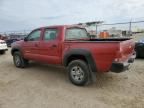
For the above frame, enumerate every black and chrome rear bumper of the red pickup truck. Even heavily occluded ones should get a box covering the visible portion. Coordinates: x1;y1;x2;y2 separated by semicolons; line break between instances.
110;53;136;73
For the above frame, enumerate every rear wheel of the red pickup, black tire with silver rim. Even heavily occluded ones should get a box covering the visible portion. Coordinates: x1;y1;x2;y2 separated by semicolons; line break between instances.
67;60;90;86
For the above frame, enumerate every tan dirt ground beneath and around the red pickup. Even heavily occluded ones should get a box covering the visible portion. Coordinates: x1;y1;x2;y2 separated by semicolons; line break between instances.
0;36;144;108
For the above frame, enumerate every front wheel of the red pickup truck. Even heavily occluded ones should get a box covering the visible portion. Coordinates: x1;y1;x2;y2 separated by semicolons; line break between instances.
13;51;28;68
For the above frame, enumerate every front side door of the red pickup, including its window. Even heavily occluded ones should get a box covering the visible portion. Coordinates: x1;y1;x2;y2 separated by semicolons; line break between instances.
23;29;41;60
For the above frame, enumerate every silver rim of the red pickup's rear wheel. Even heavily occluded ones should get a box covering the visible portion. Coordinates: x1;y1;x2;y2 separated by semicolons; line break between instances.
71;66;84;82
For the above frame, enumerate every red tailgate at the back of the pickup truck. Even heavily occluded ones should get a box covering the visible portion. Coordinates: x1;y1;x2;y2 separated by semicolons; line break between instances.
119;39;135;61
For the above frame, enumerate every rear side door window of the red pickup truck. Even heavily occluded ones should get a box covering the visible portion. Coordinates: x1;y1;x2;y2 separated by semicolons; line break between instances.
44;29;58;41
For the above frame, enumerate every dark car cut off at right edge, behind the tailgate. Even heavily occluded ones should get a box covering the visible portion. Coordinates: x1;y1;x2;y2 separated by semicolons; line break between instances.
135;39;144;58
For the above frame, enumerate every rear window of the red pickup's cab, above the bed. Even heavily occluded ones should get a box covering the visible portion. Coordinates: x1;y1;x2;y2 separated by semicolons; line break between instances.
66;28;88;40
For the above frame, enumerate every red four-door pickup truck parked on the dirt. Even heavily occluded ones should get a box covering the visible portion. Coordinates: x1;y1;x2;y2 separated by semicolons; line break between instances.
11;25;135;85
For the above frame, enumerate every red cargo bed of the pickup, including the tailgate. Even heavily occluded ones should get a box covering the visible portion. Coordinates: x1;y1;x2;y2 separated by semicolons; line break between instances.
65;38;134;72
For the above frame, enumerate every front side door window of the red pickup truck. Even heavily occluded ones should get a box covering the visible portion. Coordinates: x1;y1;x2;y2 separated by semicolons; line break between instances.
27;30;41;41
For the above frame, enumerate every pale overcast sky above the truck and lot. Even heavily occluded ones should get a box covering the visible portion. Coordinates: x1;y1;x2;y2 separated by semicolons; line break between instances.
0;0;144;32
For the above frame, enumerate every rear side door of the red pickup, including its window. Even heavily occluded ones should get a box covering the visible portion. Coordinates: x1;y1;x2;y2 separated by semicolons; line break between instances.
40;28;61;64
